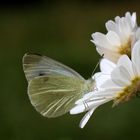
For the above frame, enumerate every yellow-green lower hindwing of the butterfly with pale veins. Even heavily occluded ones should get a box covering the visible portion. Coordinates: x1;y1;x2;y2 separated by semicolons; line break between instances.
28;75;85;118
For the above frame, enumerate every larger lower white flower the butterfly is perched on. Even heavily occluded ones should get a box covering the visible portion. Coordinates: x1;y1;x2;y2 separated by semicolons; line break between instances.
70;41;140;128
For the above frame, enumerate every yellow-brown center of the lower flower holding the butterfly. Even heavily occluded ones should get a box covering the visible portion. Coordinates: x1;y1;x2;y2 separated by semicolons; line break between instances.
113;77;140;106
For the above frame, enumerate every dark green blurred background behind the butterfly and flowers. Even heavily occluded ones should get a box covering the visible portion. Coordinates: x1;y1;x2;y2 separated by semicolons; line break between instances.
0;0;140;140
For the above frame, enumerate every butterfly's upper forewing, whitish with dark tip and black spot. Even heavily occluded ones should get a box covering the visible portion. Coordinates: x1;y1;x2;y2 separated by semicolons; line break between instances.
23;54;84;82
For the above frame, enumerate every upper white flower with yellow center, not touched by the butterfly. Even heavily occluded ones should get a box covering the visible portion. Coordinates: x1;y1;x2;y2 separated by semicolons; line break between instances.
91;12;140;63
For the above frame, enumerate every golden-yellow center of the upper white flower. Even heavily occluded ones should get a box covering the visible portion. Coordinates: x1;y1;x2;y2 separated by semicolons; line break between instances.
119;39;131;57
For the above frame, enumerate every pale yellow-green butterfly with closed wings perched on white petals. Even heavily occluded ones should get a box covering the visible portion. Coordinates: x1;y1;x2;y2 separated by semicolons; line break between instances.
23;53;95;118
